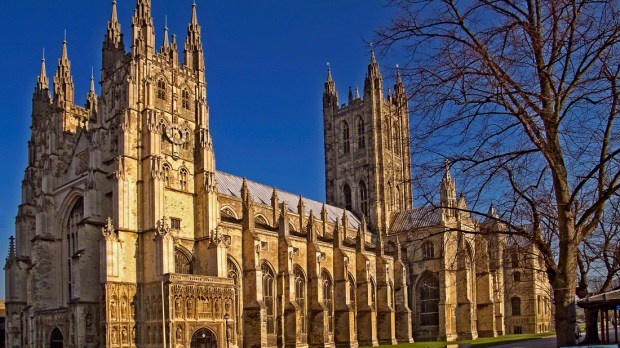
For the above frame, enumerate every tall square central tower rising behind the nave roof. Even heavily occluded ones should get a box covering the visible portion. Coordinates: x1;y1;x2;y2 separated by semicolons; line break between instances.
323;51;413;233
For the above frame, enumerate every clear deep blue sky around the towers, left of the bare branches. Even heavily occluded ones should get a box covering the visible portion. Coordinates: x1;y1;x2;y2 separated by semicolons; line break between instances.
0;0;398;298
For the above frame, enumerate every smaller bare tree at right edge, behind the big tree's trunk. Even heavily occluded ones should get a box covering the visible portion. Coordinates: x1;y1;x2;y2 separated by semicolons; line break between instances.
577;196;620;343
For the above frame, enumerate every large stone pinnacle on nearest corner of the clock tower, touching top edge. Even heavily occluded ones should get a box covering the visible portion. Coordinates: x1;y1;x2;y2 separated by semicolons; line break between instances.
131;0;155;58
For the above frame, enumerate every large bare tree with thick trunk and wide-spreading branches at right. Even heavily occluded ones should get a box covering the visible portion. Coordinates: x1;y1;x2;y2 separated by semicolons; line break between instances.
378;0;620;345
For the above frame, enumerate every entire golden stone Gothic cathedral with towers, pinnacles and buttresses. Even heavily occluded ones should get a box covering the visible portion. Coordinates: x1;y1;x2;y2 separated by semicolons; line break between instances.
4;0;551;348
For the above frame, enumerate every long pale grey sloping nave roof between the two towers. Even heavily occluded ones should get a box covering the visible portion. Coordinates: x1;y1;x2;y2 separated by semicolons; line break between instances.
215;171;360;229
